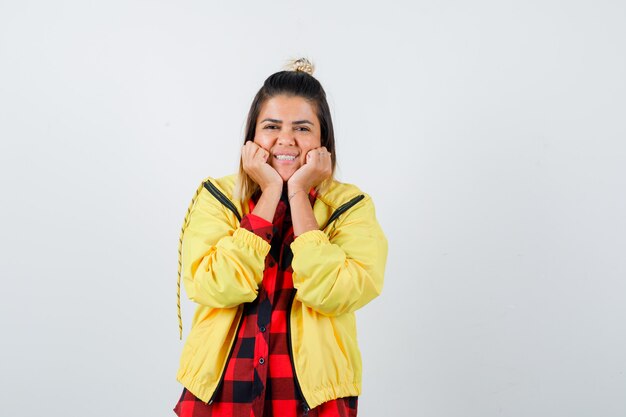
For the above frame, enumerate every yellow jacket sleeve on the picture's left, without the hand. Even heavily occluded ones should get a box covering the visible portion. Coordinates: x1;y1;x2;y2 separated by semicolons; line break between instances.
182;184;270;308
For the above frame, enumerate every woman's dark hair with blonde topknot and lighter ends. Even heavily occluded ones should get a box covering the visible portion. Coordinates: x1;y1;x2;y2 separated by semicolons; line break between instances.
234;58;337;203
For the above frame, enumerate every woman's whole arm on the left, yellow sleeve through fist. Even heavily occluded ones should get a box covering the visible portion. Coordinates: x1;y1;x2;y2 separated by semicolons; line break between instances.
182;141;283;308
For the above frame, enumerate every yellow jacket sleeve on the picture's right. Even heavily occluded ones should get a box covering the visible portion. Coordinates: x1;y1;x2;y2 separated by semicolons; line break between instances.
291;196;387;316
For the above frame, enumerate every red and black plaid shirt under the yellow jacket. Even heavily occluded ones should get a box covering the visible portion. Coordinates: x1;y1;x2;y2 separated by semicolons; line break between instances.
174;189;358;417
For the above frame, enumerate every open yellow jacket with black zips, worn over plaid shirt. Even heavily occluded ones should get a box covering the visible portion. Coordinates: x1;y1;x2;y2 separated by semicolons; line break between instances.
176;174;387;408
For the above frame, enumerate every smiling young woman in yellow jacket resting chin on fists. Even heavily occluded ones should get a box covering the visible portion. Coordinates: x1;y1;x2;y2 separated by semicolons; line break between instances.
174;59;387;417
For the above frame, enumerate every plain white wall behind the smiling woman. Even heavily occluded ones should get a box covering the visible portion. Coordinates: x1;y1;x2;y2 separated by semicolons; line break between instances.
0;0;626;417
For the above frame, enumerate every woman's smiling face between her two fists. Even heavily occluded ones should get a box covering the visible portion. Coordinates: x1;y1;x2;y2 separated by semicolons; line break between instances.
254;95;321;181
